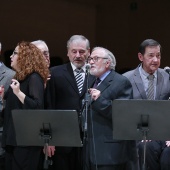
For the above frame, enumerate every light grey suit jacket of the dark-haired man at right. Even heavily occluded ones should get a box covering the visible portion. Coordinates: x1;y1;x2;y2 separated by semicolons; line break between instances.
123;67;170;100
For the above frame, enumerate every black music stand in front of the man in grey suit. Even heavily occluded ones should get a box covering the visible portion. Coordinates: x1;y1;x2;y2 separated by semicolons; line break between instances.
112;99;170;169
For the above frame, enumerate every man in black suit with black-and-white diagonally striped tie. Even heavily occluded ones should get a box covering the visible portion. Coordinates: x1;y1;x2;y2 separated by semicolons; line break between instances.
46;35;94;170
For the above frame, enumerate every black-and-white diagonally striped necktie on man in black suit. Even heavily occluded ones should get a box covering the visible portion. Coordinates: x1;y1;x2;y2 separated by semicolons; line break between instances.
75;68;83;93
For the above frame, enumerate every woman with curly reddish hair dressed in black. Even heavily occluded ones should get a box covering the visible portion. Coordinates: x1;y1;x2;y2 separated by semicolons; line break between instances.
0;42;49;170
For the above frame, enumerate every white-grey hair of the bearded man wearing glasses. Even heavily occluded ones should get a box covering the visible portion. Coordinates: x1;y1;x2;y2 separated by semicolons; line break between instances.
92;47;116;70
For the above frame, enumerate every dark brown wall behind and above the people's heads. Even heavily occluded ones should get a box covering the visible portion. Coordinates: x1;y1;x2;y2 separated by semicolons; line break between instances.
0;0;170;72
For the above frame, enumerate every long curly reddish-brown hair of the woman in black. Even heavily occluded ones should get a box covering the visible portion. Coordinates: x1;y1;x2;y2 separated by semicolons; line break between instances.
15;41;49;82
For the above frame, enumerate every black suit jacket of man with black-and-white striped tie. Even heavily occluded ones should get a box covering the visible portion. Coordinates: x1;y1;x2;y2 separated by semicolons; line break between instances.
45;63;94;112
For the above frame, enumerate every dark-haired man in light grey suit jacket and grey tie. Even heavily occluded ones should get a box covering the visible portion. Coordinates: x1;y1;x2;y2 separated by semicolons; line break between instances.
123;39;170;170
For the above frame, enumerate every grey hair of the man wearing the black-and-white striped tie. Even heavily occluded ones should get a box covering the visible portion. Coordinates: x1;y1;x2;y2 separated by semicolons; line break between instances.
67;35;90;49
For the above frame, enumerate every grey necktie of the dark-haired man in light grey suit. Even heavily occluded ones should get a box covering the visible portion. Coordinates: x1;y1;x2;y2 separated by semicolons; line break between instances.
147;74;154;100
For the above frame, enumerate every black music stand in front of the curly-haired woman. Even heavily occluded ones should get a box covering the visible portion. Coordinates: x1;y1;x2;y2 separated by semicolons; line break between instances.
12;110;82;169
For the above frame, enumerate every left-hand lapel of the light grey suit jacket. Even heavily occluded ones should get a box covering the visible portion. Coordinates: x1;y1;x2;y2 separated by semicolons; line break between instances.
133;67;147;99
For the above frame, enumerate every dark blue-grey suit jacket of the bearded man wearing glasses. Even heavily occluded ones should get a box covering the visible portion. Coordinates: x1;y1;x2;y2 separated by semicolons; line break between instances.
87;70;135;165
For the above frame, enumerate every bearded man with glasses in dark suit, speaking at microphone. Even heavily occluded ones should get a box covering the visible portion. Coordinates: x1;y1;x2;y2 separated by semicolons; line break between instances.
86;47;135;170
